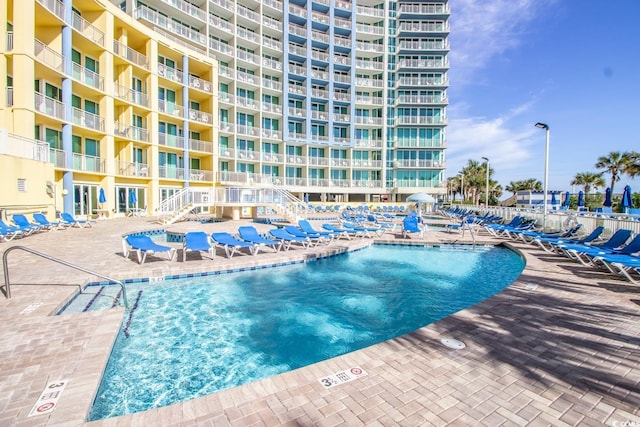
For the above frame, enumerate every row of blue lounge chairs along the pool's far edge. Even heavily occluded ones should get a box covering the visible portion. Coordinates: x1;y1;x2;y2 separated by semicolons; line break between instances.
122;220;368;264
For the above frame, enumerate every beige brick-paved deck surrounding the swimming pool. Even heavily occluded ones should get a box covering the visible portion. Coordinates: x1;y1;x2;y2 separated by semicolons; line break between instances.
0;218;640;426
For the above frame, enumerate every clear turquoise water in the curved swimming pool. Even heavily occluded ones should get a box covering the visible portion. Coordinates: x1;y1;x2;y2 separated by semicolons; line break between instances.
77;245;524;420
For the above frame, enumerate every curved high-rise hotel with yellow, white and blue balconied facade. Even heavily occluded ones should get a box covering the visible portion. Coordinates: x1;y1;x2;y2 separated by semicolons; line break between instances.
0;0;449;219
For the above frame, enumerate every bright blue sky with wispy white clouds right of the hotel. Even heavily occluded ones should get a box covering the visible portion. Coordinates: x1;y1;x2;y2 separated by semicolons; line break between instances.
446;0;640;198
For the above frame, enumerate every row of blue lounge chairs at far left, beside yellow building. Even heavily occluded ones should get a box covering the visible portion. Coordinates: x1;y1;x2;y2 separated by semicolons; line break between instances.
0;212;95;241
